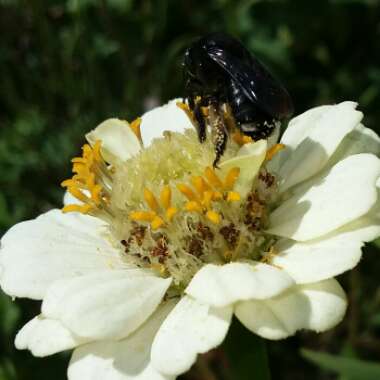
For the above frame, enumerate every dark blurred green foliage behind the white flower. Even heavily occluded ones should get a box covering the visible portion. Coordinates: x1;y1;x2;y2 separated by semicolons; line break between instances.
0;0;380;380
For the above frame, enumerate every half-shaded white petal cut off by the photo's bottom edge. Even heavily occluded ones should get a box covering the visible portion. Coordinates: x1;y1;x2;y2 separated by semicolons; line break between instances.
68;303;174;380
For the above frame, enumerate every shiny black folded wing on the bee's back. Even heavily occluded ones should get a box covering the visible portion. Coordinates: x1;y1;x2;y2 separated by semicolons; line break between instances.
207;46;293;118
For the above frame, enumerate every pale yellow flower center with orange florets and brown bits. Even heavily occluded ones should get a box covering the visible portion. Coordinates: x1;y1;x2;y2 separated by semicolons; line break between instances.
62;123;278;289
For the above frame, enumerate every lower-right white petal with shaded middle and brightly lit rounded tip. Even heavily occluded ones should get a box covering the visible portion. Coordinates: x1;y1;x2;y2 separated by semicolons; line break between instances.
235;279;347;339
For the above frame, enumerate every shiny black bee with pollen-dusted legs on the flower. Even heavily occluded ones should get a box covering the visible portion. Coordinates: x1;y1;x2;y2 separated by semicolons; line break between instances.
183;33;293;166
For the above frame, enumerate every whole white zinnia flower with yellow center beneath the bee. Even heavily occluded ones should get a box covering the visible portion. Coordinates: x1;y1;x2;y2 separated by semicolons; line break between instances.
0;102;380;380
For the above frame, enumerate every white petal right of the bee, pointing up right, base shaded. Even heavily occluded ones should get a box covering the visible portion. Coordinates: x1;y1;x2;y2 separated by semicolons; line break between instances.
279;102;363;191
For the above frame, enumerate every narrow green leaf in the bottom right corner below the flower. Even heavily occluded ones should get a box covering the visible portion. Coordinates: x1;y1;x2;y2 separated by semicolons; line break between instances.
301;349;380;380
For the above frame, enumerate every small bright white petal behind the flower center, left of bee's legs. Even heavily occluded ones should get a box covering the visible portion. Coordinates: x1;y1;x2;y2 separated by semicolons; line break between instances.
140;99;194;147
